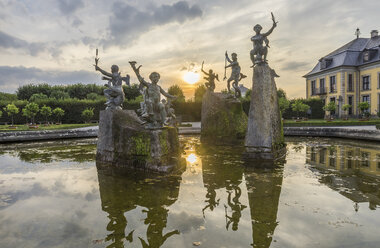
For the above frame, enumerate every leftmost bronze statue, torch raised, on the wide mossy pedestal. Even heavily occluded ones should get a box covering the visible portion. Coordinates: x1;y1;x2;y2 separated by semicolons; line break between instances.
94;51;129;109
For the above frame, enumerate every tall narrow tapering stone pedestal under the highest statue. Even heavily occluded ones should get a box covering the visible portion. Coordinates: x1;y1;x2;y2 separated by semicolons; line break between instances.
245;64;284;159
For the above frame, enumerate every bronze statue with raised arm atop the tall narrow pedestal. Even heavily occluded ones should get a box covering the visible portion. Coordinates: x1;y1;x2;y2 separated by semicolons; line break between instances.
250;13;277;67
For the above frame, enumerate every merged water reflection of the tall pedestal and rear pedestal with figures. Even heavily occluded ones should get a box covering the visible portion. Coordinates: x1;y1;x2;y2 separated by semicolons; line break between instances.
198;142;284;247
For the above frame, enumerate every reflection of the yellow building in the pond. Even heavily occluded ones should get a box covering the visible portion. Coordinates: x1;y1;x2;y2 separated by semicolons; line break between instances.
306;140;380;211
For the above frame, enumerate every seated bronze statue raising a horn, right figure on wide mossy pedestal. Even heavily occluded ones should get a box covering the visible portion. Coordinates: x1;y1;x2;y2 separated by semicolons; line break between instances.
129;61;176;129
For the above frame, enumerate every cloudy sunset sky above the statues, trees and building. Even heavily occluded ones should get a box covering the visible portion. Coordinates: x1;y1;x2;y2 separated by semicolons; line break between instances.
0;0;380;99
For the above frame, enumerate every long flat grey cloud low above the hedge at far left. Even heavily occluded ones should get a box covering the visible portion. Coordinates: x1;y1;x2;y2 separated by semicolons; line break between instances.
0;66;100;92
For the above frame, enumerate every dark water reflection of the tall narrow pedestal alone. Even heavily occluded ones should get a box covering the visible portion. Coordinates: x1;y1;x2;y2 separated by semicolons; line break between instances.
244;157;285;247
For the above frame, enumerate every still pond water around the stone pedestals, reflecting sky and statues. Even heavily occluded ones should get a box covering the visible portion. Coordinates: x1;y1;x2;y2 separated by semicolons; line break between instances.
0;136;380;248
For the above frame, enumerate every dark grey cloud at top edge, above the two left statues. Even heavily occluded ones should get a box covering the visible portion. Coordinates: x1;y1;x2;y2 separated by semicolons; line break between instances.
104;1;203;45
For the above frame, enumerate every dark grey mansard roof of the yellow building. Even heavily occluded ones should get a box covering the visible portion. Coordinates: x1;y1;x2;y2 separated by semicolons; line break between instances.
305;36;380;77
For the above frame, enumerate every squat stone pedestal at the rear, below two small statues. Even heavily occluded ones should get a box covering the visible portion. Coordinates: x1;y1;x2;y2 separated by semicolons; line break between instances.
201;90;247;144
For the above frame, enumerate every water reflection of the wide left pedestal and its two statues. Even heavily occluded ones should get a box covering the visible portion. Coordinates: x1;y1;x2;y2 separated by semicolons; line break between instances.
97;167;181;248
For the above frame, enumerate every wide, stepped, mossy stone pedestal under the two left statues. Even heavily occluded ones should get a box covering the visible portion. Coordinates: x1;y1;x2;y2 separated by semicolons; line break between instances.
96;109;183;172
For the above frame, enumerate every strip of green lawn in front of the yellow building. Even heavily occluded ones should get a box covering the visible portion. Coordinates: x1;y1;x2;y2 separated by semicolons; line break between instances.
284;119;380;127
